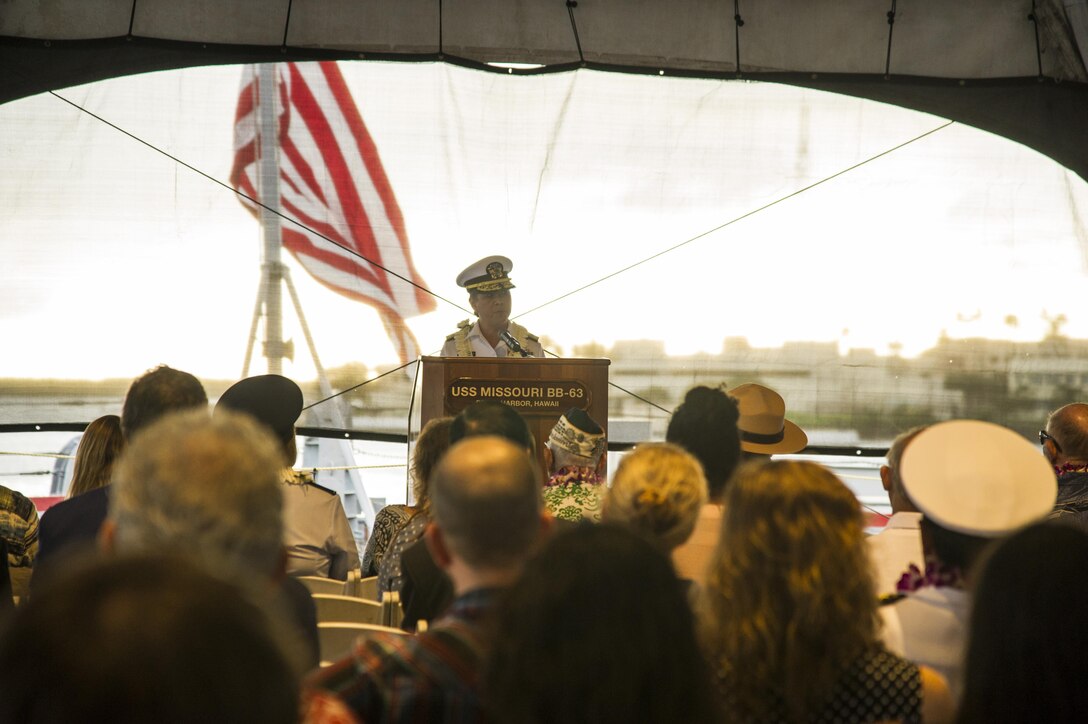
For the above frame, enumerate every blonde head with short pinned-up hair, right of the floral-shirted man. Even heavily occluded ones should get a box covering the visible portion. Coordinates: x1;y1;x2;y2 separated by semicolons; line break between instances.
603;442;707;553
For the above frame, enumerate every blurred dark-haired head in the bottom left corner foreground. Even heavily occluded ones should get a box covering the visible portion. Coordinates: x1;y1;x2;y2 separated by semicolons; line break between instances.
0;556;298;724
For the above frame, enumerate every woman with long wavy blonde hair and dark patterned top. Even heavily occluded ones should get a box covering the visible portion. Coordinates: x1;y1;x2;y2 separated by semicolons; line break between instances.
700;462;953;722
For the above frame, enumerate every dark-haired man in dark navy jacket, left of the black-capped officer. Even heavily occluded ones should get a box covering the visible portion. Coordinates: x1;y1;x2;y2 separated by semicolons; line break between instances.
30;365;208;588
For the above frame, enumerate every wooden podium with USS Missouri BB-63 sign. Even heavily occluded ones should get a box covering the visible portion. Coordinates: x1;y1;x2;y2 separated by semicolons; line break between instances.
420;357;610;469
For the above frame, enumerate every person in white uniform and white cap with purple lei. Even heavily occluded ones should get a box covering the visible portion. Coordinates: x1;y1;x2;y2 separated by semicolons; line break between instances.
881;420;1056;700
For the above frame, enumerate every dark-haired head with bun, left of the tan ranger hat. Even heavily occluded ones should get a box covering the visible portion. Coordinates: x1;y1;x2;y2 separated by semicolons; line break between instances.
665;385;741;500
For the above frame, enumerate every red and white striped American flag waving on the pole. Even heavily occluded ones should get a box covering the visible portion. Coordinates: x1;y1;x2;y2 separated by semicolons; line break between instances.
231;62;434;364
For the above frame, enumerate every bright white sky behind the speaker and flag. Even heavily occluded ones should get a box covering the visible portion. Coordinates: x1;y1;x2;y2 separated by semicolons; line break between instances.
0;63;1088;379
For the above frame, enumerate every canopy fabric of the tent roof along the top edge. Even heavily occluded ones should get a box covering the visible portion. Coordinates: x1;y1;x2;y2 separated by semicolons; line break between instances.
0;0;1088;179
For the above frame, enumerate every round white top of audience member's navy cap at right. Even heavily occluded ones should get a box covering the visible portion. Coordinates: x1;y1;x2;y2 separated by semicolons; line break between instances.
900;420;1058;538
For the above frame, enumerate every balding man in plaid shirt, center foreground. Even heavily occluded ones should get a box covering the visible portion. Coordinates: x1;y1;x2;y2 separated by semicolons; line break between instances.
304;435;551;722
